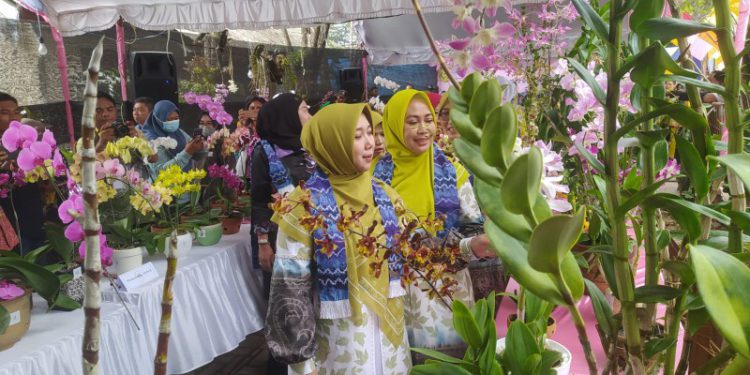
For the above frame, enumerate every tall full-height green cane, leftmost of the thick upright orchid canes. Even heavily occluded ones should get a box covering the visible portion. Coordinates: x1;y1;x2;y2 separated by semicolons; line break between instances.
604;0;643;373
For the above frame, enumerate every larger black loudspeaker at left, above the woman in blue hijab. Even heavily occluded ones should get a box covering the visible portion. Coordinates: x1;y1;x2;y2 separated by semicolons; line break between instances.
130;52;178;104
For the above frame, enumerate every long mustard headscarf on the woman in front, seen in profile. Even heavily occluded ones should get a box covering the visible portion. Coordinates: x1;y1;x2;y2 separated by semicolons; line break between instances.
274;104;404;346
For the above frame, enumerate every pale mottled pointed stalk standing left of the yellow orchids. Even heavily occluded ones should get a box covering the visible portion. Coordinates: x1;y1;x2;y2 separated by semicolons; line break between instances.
78;37;104;375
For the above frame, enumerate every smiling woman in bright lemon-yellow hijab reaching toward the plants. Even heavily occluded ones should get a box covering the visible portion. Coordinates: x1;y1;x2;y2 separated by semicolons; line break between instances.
373;90;494;362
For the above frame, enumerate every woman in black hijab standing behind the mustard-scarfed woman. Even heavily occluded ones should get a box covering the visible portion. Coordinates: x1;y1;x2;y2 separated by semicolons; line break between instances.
251;94;315;374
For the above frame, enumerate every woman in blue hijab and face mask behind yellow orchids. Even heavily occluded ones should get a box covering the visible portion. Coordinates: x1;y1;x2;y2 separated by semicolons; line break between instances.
143;100;206;175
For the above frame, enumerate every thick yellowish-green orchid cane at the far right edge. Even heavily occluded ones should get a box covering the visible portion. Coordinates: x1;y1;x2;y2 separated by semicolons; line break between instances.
714;0;747;253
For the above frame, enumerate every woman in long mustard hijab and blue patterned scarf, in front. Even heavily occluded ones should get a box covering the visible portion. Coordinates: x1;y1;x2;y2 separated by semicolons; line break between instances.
266;104;411;374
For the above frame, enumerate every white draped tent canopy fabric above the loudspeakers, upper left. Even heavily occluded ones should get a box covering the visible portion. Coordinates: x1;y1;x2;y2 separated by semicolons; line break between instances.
17;0;453;36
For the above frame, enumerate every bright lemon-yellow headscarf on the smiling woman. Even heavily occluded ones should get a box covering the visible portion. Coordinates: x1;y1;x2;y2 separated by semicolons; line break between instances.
383;89;468;218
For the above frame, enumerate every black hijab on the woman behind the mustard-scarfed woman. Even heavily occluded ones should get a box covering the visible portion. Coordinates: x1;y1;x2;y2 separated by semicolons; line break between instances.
256;94;302;150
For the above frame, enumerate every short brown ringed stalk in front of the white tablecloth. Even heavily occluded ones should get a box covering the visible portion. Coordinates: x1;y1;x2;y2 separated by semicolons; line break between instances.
154;231;177;375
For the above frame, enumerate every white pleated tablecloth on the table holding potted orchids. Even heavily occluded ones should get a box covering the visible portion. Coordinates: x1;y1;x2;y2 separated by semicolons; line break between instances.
0;225;265;375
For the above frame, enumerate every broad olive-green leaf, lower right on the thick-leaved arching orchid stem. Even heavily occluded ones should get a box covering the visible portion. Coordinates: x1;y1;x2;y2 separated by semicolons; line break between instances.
529;208;586;274
